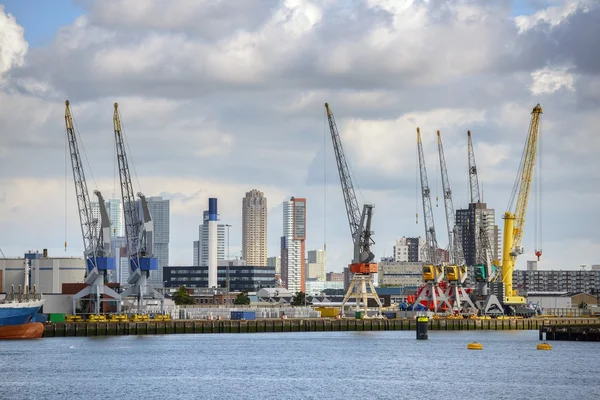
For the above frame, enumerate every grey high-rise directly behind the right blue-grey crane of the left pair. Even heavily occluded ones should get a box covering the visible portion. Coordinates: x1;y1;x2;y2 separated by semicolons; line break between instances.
146;196;170;287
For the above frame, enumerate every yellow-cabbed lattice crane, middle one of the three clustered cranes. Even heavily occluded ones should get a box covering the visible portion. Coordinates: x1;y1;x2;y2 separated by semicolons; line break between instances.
437;130;476;310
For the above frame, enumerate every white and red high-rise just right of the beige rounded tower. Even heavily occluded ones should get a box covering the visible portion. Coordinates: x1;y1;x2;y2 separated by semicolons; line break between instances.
281;197;306;292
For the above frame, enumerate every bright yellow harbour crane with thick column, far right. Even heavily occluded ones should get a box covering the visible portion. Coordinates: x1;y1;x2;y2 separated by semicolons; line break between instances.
502;104;542;305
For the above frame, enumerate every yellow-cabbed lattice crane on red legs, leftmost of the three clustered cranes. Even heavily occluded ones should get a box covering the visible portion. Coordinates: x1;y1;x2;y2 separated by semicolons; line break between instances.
413;128;452;311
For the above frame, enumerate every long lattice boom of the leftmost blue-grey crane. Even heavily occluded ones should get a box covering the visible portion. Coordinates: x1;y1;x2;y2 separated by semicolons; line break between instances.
65;100;98;260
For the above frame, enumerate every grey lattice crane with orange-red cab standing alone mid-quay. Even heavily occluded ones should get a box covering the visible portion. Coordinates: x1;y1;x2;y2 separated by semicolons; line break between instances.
325;103;382;317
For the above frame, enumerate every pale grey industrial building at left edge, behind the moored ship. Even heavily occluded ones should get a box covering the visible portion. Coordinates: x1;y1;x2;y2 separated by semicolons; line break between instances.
0;250;85;294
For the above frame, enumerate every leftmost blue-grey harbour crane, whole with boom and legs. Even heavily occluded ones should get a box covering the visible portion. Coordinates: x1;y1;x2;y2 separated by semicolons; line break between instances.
65;100;121;315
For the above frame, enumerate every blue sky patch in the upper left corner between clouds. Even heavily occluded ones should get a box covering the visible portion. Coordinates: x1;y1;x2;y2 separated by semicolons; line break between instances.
0;0;84;47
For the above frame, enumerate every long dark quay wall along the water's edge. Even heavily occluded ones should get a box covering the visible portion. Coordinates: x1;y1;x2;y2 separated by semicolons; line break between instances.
44;318;598;337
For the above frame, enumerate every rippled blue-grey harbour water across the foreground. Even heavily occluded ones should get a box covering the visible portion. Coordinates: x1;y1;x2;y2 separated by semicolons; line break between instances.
0;331;600;400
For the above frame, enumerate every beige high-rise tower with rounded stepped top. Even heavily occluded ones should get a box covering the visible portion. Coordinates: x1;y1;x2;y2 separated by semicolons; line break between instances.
242;189;267;266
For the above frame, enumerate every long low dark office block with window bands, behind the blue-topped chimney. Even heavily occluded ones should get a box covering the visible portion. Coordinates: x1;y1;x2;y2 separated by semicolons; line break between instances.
164;260;275;292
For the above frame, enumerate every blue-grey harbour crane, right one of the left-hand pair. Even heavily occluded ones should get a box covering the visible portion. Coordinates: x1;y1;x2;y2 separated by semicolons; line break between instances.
113;103;164;312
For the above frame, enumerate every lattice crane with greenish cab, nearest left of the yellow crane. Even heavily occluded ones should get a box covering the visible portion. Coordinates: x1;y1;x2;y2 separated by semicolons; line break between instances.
467;131;504;315
